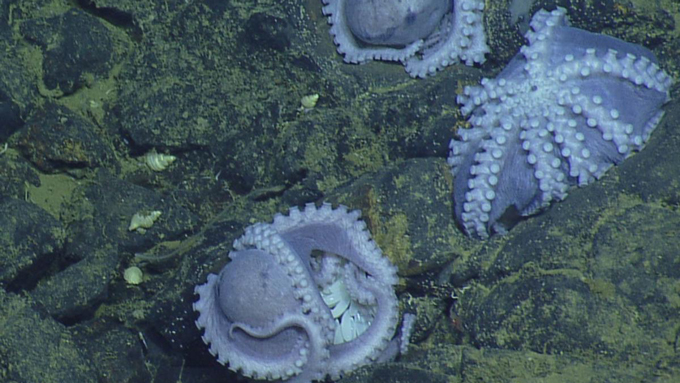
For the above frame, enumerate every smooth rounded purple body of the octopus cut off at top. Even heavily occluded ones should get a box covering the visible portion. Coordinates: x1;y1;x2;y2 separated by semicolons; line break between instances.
345;0;453;46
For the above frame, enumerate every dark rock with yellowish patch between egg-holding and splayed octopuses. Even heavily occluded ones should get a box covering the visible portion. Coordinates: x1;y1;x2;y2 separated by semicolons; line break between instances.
327;158;478;275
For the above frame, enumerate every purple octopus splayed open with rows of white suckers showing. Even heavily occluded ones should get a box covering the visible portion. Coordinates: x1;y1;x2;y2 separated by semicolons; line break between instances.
449;8;673;238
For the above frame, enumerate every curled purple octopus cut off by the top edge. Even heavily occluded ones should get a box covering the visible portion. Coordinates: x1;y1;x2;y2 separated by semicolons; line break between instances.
323;0;489;77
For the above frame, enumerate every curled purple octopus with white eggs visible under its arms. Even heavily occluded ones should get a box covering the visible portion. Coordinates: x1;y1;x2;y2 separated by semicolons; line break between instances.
194;204;414;382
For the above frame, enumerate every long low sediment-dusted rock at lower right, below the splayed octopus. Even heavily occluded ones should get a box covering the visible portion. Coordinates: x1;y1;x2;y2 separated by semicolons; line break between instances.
458;266;677;359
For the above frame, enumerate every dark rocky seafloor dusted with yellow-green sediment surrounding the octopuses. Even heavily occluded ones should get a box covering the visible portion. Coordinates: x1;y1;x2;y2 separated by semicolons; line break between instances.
0;0;680;383
